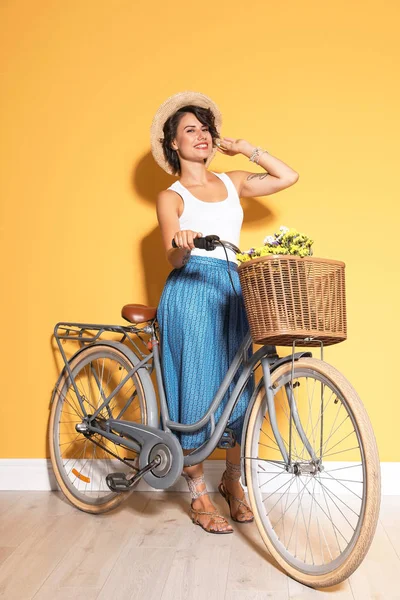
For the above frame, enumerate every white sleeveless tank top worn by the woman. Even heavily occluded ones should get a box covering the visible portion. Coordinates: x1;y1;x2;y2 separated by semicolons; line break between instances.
168;171;243;263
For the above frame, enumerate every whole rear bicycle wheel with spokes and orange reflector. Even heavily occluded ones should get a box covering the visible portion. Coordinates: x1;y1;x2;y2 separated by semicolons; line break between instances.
49;344;147;513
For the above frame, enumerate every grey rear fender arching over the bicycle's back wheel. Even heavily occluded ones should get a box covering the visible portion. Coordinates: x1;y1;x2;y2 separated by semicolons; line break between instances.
50;340;159;428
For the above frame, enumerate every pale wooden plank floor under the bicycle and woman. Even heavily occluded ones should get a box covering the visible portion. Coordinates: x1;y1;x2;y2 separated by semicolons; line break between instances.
0;492;400;600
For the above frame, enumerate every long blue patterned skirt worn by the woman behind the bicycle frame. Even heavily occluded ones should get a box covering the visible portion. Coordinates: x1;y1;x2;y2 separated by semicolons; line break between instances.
157;255;254;449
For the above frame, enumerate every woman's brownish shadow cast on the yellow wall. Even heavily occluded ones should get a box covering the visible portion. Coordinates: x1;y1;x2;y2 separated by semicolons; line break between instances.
132;152;274;306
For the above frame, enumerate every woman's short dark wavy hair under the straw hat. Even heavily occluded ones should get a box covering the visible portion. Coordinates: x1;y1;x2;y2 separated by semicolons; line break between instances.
160;104;219;175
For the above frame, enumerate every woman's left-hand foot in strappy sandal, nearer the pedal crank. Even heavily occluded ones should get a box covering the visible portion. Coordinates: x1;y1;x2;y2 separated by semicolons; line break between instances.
182;471;233;534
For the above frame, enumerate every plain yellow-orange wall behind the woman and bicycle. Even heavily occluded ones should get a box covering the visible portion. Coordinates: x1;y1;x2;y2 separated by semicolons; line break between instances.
0;0;400;461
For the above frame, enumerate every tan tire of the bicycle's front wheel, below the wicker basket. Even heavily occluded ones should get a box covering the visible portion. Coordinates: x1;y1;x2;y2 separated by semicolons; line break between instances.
245;358;381;588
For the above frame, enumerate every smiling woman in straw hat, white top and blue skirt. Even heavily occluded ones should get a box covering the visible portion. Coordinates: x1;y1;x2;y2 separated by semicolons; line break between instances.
151;92;299;533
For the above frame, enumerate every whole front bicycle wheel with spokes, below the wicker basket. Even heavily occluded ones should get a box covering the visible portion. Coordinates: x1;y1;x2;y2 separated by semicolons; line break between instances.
245;358;380;588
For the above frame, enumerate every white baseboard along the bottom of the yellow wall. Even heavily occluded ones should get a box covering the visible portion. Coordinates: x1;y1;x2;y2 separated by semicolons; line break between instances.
0;458;400;496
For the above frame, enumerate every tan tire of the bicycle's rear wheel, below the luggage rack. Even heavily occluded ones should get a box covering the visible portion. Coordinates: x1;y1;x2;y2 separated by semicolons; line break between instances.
49;344;146;514
